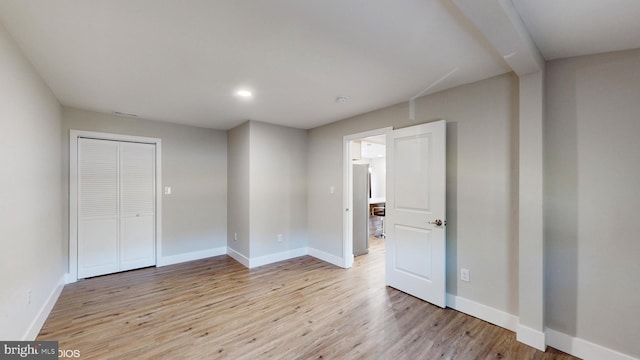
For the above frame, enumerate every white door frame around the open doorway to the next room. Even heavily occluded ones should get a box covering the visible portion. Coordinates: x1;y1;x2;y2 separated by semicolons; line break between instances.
342;126;393;269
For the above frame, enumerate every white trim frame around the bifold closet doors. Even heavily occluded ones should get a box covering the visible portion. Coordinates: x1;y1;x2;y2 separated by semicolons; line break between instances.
66;129;162;283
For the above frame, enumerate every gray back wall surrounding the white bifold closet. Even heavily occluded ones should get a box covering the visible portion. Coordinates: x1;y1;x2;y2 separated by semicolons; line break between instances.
62;107;227;258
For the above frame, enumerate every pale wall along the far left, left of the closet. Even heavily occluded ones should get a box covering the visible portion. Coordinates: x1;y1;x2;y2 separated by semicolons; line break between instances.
0;25;65;340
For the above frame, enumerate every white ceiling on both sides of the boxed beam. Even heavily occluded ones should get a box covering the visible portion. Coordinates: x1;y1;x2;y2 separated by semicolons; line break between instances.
0;0;640;129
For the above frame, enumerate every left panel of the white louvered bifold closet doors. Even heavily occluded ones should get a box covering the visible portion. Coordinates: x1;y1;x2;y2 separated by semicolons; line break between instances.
78;139;119;278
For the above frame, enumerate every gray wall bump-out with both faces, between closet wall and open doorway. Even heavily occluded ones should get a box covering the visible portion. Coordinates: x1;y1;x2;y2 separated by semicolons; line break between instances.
228;121;307;259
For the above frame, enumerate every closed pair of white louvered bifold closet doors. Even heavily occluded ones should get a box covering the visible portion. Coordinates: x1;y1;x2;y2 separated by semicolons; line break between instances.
78;138;156;278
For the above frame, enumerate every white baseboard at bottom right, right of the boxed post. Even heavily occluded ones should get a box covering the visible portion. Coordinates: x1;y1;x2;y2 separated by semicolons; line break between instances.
545;328;638;360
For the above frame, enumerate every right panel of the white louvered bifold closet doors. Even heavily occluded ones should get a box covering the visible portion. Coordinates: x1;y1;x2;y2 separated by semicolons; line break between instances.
120;142;156;271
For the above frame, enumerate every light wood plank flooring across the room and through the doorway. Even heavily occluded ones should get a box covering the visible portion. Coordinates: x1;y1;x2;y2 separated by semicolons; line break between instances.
38;238;576;360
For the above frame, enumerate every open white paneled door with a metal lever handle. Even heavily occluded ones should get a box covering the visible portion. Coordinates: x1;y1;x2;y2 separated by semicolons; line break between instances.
385;120;446;307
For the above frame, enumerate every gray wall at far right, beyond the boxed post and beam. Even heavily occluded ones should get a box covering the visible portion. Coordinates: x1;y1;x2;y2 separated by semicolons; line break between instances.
545;50;640;357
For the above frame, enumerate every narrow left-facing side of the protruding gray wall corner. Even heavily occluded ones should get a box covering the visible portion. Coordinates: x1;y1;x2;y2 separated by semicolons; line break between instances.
227;122;251;258
